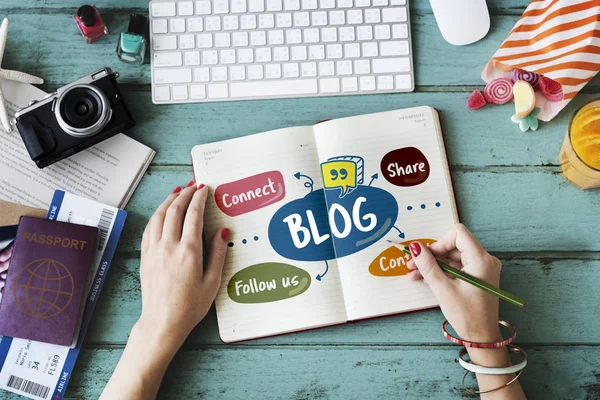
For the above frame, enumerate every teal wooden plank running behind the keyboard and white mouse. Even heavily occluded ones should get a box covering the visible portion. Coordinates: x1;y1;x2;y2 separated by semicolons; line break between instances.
3;12;599;91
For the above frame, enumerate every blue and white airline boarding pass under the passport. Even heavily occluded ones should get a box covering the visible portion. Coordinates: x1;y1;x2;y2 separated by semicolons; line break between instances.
0;190;127;400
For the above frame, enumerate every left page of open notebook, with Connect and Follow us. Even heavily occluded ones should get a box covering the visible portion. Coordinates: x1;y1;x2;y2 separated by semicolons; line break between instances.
192;127;346;343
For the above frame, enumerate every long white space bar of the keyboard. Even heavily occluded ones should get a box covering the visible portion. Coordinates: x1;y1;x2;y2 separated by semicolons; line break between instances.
231;79;317;98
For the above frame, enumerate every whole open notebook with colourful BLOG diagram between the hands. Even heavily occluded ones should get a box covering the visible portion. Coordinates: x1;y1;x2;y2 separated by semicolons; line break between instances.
192;107;458;343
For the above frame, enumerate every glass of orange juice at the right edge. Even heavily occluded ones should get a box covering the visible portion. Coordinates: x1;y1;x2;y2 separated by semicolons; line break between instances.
558;99;600;190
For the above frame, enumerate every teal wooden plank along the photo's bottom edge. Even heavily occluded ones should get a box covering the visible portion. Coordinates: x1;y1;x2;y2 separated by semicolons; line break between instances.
10;346;600;400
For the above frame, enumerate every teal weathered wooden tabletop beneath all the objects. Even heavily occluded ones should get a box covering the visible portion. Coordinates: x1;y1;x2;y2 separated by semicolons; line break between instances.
0;0;600;399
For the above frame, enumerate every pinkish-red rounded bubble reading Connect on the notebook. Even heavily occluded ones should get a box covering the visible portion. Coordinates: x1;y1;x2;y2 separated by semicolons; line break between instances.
215;171;285;217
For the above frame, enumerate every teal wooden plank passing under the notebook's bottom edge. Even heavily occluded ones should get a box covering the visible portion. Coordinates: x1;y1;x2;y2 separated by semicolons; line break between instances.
86;255;600;346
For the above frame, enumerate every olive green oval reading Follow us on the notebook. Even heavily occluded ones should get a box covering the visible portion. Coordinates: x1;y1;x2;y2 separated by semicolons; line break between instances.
227;262;311;304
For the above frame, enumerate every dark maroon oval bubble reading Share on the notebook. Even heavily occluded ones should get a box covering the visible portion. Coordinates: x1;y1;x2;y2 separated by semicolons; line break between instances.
381;147;430;186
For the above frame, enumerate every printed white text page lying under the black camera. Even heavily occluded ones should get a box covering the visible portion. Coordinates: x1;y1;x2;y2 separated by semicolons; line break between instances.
0;81;155;209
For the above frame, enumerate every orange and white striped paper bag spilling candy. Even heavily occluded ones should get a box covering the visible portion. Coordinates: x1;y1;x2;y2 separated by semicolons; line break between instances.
481;0;600;121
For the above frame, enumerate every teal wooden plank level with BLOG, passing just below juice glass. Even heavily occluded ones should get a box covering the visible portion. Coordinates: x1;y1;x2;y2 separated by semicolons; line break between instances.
120;167;600;251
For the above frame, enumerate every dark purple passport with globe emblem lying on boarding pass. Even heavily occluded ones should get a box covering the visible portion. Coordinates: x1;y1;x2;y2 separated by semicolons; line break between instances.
0;217;98;346
